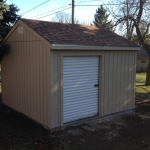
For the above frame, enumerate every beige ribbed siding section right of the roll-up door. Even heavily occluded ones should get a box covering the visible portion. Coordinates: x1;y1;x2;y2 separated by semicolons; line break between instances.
103;51;136;115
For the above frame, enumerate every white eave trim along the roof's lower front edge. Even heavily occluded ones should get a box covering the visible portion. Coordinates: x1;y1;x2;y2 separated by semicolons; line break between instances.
52;44;141;50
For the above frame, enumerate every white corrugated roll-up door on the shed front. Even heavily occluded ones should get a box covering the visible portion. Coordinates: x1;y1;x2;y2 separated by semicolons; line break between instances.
63;57;99;123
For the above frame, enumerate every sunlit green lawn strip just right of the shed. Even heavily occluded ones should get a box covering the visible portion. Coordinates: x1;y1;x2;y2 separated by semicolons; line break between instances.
136;72;150;96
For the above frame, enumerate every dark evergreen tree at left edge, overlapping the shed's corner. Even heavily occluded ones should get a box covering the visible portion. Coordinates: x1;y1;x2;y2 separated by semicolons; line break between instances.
0;0;20;61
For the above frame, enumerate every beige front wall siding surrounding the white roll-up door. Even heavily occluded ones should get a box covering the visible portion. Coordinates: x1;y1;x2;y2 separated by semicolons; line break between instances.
51;50;136;127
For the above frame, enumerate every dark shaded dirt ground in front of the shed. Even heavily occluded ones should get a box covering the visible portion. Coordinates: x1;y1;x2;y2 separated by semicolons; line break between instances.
0;103;150;150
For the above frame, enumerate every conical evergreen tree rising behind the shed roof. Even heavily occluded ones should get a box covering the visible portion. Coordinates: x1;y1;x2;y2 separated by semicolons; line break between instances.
93;5;113;29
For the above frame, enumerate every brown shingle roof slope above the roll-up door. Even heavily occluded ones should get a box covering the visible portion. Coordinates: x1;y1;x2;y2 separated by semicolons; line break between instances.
21;19;137;47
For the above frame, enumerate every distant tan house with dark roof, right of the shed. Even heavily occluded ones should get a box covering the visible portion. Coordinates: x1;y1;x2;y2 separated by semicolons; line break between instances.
136;48;149;72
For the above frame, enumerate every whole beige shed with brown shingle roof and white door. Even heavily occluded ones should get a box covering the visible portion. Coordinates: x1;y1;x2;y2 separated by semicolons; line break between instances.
2;19;139;128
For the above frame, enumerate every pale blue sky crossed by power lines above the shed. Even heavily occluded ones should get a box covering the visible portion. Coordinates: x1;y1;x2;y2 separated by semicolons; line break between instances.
6;0;106;24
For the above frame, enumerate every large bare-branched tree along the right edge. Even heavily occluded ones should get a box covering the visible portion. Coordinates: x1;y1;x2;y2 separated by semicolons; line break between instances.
112;0;150;85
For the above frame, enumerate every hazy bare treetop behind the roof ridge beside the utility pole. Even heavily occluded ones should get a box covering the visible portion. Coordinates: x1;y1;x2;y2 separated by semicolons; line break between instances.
51;11;79;24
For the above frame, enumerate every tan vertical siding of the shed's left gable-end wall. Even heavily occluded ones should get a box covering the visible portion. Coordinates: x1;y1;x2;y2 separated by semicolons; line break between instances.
2;25;51;127
